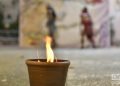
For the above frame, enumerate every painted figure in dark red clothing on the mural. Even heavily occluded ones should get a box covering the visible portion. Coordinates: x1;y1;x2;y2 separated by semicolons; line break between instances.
80;7;95;48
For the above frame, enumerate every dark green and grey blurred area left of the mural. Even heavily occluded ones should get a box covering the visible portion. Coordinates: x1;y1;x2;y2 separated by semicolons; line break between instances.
0;0;19;46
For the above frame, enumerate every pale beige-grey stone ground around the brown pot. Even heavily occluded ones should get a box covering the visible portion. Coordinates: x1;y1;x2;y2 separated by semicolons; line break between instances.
0;47;120;86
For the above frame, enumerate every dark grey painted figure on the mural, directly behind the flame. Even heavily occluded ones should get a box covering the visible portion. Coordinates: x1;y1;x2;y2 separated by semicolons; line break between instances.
47;5;57;48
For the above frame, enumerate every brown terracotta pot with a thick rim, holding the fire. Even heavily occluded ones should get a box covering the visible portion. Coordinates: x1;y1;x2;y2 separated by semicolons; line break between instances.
26;59;70;86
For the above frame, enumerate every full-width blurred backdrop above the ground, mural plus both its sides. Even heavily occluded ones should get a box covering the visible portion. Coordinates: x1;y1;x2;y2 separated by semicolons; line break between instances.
0;0;120;48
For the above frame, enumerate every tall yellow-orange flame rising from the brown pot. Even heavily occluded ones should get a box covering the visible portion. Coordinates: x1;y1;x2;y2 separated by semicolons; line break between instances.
45;36;54;63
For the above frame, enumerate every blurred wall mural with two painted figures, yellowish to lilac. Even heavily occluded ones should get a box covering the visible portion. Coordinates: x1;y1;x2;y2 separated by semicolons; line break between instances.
20;0;110;48
